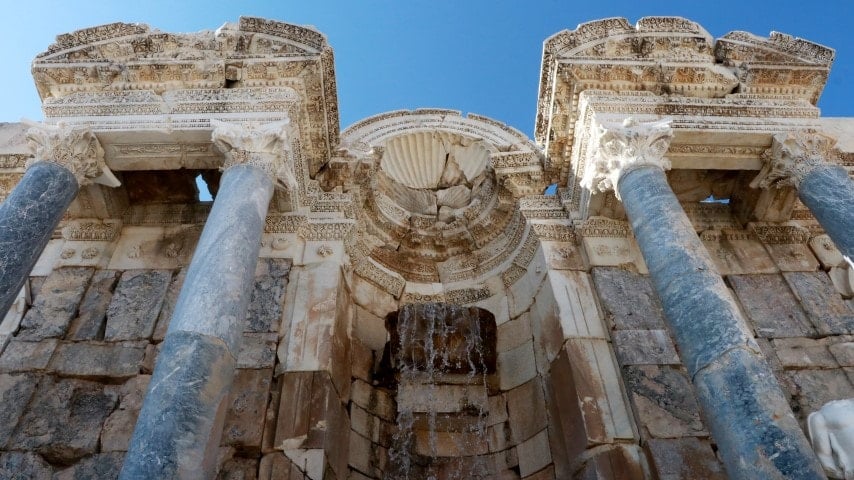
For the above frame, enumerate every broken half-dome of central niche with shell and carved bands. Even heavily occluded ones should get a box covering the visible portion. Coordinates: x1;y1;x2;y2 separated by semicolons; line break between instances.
322;110;546;284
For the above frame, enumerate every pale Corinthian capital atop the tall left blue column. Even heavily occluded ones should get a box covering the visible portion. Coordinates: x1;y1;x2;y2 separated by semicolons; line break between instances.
211;120;297;190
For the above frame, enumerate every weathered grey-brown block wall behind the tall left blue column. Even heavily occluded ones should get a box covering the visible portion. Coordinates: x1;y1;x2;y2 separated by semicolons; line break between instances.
0;259;291;478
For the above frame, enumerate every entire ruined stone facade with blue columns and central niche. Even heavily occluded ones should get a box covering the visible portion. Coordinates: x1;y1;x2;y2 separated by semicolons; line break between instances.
0;17;854;480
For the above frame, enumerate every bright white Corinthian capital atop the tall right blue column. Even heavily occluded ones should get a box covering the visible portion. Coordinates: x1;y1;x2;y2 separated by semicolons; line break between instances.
581;117;673;198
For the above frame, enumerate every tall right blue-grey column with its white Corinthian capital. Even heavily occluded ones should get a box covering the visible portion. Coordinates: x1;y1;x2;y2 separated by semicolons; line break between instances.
583;119;825;479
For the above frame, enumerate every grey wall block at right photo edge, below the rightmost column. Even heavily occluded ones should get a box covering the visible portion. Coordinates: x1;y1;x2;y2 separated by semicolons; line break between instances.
783;272;854;335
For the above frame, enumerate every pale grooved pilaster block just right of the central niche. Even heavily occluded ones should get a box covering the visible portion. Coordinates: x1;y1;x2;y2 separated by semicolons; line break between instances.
532;270;608;339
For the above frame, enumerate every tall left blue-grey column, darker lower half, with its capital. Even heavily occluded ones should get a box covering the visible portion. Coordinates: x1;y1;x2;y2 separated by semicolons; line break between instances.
120;121;294;479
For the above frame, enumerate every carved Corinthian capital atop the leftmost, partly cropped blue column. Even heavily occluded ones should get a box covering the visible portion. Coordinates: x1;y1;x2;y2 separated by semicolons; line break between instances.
27;122;121;187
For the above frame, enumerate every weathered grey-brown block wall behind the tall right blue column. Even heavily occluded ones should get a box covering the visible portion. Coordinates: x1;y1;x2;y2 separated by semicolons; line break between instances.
592;240;854;479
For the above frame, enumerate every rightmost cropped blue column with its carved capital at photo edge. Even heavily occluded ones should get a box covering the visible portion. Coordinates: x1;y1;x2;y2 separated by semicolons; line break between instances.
750;131;854;268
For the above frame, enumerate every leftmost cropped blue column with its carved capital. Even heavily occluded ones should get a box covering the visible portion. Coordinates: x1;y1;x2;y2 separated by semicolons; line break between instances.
0;124;119;317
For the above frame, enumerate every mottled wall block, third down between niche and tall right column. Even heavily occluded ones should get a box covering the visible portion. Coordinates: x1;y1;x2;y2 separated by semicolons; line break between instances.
623;365;709;438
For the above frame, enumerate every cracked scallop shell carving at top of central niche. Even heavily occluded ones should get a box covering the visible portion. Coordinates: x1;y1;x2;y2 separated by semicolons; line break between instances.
380;132;489;189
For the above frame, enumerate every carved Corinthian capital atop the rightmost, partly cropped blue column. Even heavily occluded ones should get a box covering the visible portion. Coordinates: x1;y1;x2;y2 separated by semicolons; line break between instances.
750;130;836;188
